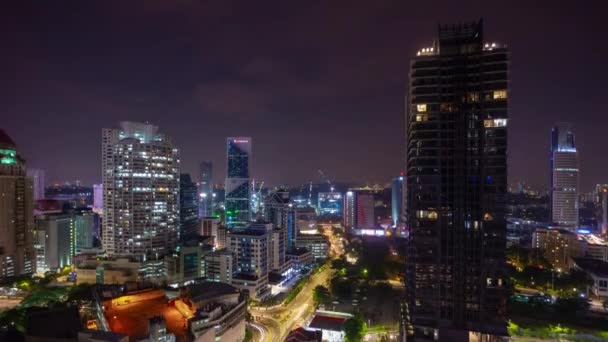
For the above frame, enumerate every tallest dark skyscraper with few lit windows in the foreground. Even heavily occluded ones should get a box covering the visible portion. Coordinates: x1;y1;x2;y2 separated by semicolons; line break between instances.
405;20;509;341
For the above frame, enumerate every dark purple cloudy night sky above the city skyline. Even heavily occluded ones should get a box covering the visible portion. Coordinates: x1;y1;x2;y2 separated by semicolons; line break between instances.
0;0;608;191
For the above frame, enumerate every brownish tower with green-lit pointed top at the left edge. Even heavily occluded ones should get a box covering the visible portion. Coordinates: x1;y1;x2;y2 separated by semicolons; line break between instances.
0;129;36;279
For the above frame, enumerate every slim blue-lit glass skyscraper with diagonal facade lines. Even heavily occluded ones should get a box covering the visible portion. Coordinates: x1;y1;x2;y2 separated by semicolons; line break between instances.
224;137;251;229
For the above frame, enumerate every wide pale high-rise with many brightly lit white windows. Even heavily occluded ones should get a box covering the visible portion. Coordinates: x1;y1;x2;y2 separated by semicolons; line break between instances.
101;122;179;259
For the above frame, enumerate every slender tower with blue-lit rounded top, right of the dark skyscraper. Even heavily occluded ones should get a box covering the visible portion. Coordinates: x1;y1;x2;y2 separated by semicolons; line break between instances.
550;123;578;230
